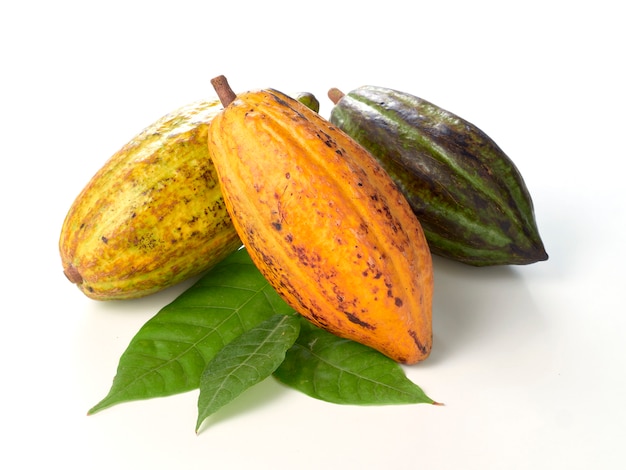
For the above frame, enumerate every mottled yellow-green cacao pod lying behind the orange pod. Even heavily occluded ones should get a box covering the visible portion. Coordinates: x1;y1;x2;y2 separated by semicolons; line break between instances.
59;101;241;300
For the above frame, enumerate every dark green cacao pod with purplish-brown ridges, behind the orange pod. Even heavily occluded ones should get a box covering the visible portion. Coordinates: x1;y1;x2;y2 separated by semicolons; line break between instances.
328;86;548;266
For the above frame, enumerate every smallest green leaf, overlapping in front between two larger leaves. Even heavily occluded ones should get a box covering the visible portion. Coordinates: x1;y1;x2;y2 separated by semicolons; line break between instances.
196;315;300;432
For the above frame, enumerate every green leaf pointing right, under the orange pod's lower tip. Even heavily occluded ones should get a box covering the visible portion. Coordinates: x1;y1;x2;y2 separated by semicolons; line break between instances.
274;324;436;405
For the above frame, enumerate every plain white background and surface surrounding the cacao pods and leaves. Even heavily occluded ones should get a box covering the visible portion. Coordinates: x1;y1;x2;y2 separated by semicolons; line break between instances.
0;0;626;470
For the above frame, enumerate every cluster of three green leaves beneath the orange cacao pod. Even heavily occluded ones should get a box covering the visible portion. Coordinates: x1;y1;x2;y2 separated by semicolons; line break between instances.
89;249;435;431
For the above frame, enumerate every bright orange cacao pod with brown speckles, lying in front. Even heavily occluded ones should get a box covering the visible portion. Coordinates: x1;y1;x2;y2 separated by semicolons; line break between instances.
209;79;433;364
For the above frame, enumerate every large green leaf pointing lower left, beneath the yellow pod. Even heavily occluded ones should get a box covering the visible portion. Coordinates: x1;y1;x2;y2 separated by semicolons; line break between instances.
89;249;293;414
